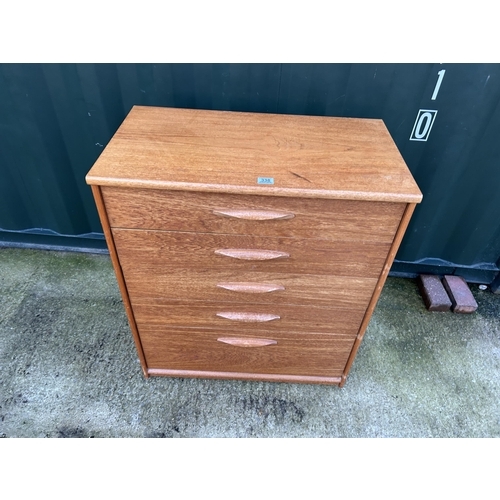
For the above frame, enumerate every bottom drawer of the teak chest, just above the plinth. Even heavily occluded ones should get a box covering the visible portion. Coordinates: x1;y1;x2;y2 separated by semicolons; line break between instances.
140;326;354;377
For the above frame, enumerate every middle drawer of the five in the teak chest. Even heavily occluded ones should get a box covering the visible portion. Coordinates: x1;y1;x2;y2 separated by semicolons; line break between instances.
120;268;377;309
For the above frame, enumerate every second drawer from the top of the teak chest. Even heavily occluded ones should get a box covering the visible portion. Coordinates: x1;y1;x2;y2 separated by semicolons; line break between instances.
113;228;390;282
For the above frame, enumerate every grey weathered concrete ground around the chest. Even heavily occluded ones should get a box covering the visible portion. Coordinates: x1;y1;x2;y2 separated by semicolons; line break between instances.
0;248;500;438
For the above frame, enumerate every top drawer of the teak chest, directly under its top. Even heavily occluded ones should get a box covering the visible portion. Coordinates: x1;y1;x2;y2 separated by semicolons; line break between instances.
102;186;405;243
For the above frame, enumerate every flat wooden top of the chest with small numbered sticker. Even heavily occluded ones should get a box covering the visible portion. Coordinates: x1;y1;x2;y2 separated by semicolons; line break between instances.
86;106;422;203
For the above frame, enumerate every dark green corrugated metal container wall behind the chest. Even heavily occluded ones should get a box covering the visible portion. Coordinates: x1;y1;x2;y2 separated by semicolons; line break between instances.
0;64;500;283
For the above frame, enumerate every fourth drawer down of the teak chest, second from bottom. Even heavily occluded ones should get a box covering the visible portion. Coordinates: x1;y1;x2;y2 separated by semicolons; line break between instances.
134;300;365;338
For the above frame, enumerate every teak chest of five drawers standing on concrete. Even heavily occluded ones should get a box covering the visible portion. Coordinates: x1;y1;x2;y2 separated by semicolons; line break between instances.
86;106;422;386
